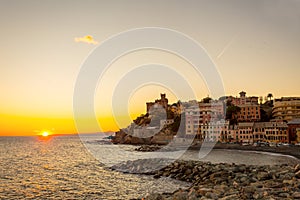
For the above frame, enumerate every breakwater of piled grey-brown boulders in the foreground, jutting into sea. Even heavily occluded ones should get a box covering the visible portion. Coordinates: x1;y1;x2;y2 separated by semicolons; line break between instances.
111;158;300;200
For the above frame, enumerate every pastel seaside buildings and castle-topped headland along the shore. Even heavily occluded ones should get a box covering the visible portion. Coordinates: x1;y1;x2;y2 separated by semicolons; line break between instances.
112;91;300;146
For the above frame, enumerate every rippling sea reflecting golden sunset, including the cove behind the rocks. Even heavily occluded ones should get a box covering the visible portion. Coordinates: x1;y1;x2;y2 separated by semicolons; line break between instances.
0;135;299;199
